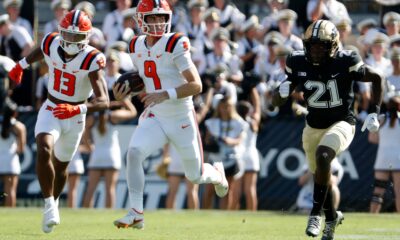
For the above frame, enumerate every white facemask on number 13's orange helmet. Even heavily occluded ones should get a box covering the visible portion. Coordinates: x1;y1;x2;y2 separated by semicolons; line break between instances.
59;27;89;55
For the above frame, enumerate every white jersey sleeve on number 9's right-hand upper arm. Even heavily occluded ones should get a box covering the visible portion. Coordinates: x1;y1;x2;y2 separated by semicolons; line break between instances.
172;37;194;72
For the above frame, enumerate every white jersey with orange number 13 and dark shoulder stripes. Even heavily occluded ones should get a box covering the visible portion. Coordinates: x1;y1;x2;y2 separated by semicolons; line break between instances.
41;32;106;102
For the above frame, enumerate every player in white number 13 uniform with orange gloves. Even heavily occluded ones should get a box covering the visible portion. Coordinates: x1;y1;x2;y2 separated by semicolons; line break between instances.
9;10;109;233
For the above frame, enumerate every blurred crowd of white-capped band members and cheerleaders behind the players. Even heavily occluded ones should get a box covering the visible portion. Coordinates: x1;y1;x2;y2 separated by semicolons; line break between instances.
0;0;400;212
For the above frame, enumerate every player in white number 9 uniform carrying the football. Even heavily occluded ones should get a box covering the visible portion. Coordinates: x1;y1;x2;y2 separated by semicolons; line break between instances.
113;0;228;229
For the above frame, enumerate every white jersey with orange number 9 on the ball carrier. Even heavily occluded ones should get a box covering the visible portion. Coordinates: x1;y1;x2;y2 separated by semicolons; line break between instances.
129;33;194;116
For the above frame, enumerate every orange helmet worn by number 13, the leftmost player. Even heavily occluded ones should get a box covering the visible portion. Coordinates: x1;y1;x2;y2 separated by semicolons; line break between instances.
58;10;92;55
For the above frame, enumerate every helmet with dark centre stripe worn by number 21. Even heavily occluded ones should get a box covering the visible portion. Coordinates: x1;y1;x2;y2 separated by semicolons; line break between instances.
303;20;339;66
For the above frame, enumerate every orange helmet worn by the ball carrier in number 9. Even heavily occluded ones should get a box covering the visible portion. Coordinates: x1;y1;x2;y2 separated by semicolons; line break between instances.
136;0;172;37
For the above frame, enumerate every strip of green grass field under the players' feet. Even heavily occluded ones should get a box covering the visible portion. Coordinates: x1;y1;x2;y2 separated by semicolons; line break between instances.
0;208;400;240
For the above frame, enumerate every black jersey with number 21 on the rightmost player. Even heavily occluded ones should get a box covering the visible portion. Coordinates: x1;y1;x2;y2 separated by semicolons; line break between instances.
286;50;365;129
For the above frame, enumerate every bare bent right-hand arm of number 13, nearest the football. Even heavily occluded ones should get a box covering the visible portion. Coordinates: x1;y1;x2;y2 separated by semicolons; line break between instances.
86;69;110;113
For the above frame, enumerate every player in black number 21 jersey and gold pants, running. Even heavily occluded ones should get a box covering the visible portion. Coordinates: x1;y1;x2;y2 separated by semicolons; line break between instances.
273;20;384;240
